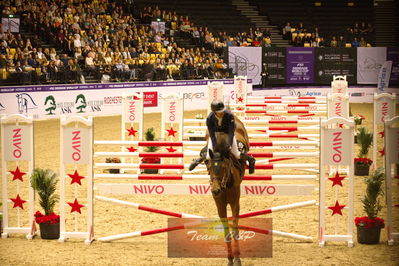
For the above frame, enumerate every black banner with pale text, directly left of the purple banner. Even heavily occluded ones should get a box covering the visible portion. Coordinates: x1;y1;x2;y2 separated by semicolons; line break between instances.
263;47;286;84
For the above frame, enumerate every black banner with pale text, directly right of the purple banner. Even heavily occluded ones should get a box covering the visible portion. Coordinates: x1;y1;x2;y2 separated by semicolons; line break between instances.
315;47;356;84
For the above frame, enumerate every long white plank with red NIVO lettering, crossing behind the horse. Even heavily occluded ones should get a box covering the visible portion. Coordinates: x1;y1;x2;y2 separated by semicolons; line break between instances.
97;183;315;196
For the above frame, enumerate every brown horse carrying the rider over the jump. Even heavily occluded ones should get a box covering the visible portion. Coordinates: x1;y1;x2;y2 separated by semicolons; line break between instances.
205;116;249;265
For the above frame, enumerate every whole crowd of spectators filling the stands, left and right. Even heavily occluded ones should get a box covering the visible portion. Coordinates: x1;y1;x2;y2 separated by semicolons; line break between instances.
0;0;378;84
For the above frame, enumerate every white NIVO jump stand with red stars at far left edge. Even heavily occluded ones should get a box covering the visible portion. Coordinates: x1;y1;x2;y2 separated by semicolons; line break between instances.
0;114;36;239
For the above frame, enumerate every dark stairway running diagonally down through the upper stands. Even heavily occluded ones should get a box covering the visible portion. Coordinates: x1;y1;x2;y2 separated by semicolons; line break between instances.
232;0;291;47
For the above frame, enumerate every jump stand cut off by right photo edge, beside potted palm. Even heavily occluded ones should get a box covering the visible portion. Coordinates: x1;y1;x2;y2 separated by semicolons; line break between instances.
384;116;399;245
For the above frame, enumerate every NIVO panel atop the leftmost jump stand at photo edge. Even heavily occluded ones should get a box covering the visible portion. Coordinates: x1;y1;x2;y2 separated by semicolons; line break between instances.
4;125;32;161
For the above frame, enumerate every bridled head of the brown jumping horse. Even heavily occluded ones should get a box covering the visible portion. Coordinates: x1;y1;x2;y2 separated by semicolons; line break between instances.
207;145;231;197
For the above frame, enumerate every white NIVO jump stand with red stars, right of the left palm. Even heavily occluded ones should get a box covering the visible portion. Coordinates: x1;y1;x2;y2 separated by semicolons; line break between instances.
59;116;94;244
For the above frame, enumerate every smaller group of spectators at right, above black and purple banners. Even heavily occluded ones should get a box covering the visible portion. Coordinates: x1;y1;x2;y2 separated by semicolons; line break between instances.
282;22;374;47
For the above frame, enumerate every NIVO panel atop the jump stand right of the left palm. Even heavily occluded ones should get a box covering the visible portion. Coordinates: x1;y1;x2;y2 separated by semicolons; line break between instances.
61;127;92;164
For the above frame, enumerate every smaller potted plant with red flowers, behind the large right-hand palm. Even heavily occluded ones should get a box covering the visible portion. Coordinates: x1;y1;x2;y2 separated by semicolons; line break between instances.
355;127;373;176
